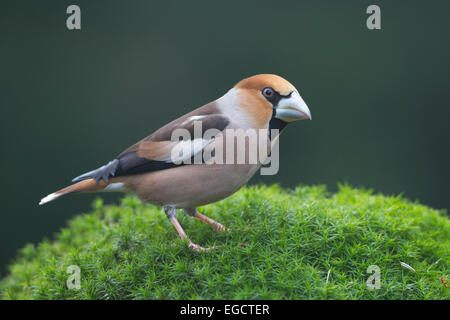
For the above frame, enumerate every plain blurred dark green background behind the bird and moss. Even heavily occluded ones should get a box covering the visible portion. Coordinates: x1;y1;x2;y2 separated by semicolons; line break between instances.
0;0;450;273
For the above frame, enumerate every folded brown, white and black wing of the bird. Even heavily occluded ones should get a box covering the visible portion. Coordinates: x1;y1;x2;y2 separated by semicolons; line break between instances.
72;112;230;182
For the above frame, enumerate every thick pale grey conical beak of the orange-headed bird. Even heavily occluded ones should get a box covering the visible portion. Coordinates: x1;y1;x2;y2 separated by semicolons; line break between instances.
275;91;312;122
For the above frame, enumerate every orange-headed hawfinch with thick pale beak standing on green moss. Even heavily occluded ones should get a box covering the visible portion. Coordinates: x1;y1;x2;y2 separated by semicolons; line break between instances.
39;74;312;252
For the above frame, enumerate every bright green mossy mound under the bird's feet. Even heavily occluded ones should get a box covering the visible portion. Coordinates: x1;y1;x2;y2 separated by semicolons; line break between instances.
0;186;450;299
